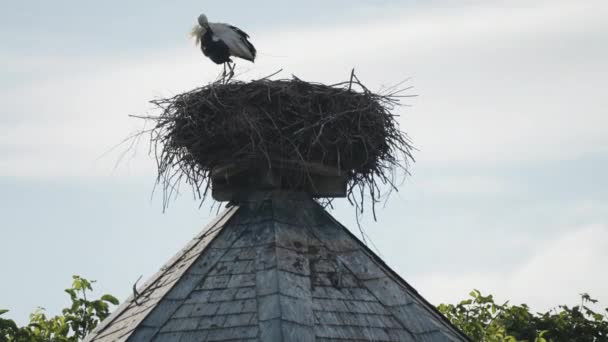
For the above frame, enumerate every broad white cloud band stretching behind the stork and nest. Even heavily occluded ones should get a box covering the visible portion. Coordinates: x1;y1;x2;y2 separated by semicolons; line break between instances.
0;2;608;177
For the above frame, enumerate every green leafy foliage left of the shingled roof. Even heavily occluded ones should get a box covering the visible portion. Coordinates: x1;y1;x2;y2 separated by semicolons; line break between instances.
0;275;118;342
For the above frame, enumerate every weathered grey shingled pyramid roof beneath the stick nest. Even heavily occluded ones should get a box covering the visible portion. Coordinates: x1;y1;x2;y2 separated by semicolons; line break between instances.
85;192;468;342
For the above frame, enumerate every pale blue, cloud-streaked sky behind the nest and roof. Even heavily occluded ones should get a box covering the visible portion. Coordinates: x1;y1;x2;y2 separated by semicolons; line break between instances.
0;0;608;323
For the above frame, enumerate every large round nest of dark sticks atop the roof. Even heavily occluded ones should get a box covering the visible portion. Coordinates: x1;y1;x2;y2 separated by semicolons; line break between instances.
146;72;413;218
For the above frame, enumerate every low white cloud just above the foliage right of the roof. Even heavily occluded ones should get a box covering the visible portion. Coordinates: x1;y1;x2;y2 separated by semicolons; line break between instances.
410;225;608;311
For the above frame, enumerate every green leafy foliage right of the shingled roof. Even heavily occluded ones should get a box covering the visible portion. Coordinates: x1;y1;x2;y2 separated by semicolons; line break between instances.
438;290;608;342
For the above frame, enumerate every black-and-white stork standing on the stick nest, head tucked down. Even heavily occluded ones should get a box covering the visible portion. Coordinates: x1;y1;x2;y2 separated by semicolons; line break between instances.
191;14;256;77
